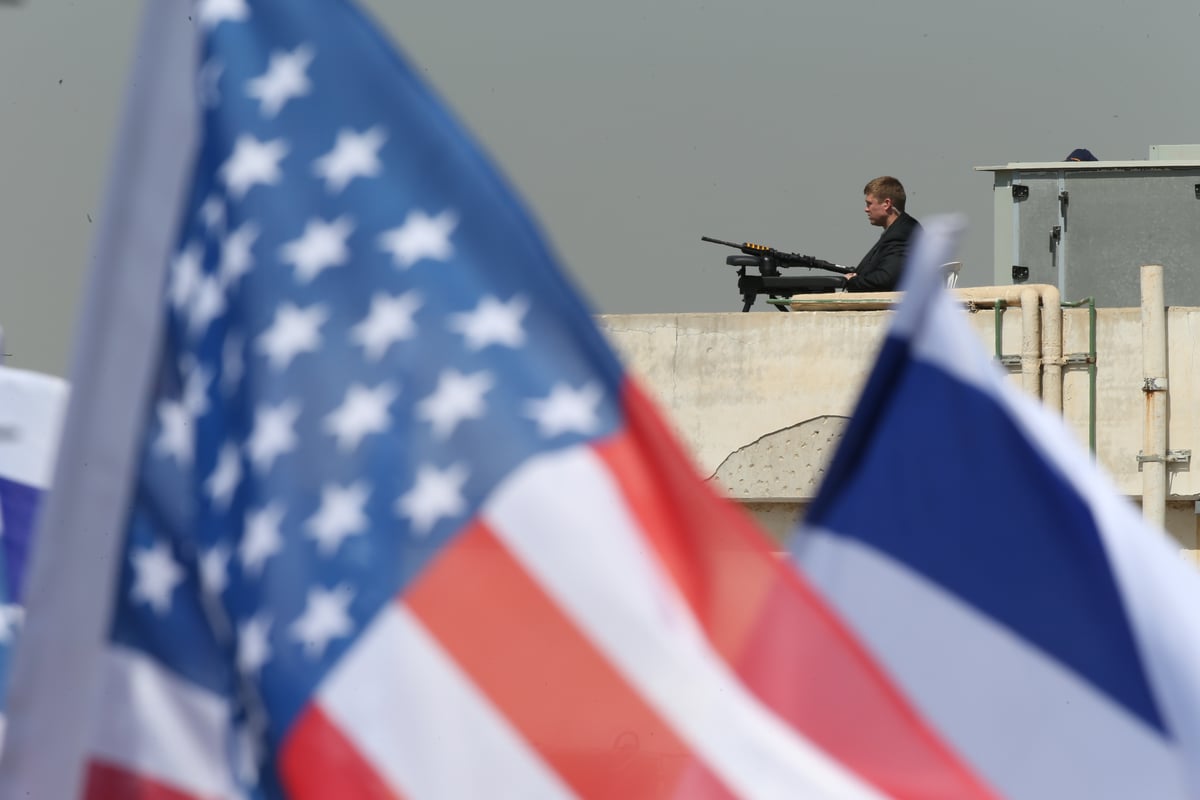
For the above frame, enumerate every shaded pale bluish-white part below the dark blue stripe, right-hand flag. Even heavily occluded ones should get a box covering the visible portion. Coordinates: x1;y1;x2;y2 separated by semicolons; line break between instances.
804;529;1188;800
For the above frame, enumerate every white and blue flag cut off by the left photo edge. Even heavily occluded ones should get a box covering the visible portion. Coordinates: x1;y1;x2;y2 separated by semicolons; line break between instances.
0;367;67;730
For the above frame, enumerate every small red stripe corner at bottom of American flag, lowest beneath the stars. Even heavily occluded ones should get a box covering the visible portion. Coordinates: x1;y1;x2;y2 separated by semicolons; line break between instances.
280;705;403;800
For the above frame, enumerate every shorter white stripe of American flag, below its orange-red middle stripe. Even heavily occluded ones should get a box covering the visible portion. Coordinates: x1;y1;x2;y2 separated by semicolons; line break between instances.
318;603;574;800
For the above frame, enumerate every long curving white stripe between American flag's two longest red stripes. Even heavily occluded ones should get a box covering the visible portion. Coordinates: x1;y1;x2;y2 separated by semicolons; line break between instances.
484;447;878;798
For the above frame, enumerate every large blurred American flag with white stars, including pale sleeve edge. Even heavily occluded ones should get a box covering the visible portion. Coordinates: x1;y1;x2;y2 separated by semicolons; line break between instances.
0;0;990;799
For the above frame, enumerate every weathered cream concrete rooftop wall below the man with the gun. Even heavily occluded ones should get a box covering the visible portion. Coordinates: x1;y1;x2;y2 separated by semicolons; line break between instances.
599;299;1200;552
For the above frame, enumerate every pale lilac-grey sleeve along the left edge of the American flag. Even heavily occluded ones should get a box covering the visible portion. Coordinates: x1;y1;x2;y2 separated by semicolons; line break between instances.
0;0;197;798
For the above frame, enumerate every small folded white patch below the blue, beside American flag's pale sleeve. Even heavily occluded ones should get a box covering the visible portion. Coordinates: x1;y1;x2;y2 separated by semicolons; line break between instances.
91;646;235;798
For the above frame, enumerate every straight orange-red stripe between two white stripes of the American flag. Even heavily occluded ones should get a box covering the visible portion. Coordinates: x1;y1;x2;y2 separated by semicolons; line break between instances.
404;522;731;798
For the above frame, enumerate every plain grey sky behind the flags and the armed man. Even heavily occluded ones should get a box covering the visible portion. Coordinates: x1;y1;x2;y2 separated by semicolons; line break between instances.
0;0;1200;374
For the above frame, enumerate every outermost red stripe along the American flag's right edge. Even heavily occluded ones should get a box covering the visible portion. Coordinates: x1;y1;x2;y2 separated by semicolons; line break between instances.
596;381;996;799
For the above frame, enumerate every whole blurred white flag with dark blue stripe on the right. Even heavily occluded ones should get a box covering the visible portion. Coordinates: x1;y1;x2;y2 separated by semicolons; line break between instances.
794;218;1200;800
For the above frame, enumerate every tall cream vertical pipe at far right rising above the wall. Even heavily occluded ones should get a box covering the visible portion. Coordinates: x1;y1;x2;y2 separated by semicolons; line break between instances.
1141;264;1166;528
